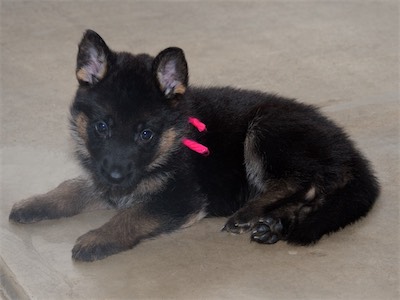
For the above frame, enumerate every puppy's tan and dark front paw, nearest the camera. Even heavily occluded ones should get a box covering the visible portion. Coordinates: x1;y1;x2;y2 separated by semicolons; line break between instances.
72;229;126;261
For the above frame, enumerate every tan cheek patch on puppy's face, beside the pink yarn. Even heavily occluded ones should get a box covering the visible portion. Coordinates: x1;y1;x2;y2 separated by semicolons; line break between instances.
147;128;178;171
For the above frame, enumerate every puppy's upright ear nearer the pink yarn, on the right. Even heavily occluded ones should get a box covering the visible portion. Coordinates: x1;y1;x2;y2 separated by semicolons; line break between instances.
153;47;188;98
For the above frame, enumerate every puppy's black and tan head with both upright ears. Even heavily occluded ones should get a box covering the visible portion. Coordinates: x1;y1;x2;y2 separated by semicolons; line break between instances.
71;31;187;189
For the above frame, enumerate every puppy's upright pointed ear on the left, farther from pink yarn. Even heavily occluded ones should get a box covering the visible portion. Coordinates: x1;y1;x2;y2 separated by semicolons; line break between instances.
76;30;111;85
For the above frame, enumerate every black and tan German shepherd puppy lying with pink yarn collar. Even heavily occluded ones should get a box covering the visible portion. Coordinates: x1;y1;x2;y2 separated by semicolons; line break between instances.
10;30;379;261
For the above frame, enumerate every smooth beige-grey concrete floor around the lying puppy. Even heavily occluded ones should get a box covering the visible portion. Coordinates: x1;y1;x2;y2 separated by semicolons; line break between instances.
0;1;400;300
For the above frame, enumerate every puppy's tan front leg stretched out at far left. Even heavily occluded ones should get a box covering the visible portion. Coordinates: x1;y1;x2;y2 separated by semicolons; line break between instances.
9;177;110;224
